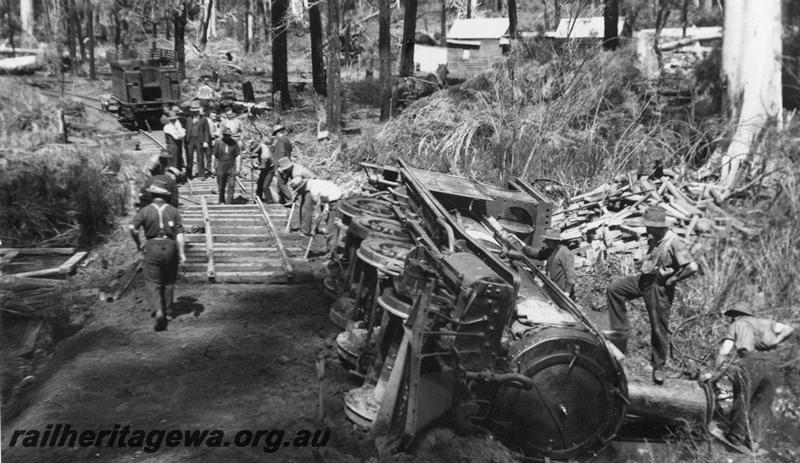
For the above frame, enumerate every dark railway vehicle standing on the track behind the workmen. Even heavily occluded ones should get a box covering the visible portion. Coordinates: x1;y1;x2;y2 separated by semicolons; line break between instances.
104;48;181;126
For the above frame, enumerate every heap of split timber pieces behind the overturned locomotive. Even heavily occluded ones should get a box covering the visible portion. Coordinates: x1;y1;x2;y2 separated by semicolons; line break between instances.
552;169;758;266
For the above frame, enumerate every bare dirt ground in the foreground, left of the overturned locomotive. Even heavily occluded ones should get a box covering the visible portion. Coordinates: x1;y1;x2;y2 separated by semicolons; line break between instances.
3;285;366;462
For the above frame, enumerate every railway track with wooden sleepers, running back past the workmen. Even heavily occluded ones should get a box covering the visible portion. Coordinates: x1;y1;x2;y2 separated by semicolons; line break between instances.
32;84;310;283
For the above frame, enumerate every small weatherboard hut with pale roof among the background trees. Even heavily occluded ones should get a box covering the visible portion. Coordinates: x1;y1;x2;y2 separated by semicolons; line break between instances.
447;18;509;80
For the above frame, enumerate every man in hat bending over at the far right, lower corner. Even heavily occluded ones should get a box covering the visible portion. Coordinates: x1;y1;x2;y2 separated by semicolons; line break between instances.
700;302;794;449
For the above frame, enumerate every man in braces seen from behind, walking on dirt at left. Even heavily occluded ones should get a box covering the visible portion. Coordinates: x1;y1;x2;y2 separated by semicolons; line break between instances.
128;179;186;331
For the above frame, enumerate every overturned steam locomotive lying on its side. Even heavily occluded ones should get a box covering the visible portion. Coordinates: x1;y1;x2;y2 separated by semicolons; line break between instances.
325;163;627;459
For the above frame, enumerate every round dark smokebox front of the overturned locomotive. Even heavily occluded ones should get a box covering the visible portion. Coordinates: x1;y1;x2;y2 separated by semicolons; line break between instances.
492;327;625;459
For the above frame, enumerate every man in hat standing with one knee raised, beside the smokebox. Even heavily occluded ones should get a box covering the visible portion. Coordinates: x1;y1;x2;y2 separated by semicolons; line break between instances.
605;207;698;384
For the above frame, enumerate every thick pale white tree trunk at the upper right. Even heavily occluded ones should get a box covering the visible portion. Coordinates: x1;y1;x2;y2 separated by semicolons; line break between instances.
720;0;783;192
